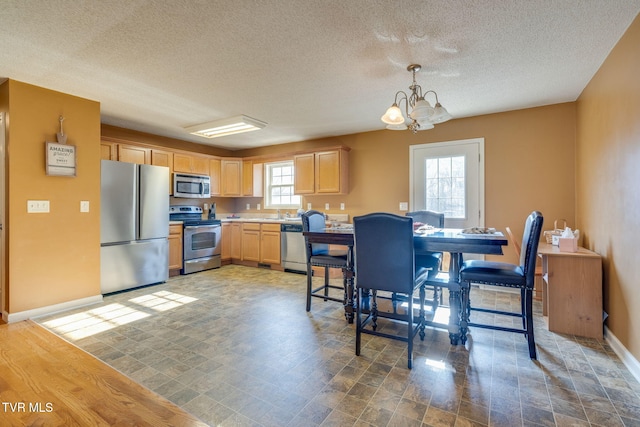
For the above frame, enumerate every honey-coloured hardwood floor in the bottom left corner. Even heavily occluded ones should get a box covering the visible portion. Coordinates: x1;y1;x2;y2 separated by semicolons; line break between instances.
0;321;206;426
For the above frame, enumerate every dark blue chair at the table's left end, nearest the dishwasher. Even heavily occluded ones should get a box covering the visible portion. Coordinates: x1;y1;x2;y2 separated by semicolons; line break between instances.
302;210;348;311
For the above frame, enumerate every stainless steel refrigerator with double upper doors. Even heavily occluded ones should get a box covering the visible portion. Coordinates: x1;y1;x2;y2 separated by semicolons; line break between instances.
100;160;169;294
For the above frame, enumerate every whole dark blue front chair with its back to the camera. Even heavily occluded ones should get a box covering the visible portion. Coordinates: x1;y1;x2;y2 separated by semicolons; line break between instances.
353;213;428;369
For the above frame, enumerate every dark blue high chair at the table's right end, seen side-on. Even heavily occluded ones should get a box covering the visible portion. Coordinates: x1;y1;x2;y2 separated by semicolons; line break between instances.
460;211;543;359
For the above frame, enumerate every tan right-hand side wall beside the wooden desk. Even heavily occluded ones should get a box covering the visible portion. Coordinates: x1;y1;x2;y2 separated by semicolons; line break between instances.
576;16;640;360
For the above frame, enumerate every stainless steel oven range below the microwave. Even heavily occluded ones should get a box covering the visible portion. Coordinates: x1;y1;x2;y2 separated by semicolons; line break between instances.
169;205;222;274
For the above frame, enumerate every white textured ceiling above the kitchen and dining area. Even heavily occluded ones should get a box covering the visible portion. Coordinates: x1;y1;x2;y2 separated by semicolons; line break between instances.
0;0;640;149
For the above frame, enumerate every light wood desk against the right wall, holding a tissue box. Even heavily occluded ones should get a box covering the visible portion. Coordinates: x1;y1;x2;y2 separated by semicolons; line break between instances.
538;243;603;339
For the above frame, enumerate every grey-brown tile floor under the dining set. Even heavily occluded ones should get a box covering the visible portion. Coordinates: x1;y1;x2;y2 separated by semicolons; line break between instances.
37;266;640;427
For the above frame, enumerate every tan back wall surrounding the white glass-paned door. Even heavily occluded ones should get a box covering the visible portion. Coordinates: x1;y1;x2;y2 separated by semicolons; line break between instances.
240;103;575;261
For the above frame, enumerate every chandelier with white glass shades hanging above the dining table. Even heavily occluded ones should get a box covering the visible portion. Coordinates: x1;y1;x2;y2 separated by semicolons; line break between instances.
381;64;452;133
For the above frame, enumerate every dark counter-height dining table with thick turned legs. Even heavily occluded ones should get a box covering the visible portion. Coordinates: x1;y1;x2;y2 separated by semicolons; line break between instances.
303;225;509;345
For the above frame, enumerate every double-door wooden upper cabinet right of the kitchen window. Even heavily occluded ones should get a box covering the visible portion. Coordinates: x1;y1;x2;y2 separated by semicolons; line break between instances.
293;147;349;194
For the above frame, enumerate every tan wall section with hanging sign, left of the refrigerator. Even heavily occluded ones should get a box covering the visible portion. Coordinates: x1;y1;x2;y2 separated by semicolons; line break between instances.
1;80;100;313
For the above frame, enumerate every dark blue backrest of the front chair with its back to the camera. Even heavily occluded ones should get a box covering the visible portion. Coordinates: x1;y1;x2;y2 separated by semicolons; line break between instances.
353;213;415;293
